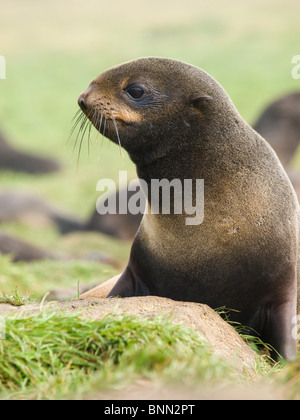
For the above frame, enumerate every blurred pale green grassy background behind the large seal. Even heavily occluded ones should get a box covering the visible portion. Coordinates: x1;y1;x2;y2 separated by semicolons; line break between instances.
0;0;300;296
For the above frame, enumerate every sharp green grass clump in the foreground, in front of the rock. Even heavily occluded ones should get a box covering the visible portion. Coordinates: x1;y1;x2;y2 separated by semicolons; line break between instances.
0;312;232;399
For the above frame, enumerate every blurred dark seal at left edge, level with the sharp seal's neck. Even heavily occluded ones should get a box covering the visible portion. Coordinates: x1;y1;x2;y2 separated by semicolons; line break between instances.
0;133;61;174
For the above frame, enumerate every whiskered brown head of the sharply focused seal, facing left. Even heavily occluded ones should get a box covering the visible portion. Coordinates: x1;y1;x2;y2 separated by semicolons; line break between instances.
78;57;236;164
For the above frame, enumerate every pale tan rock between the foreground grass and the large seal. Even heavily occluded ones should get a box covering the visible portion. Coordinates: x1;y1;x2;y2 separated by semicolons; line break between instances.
0;296;258;379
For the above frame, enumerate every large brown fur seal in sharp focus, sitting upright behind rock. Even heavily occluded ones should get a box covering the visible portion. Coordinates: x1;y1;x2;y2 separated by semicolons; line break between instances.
78;57;299;359
